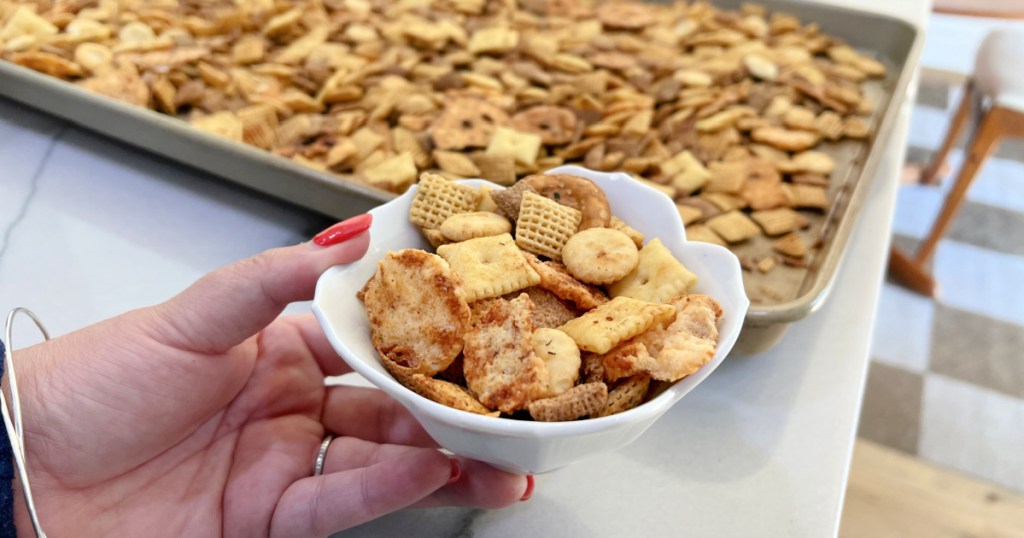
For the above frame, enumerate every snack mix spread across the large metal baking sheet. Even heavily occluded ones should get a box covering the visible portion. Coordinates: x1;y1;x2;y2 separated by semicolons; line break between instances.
0;0;886;272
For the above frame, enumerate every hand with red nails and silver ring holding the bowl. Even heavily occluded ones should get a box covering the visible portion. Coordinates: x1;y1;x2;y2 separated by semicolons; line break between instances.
15;216;532;537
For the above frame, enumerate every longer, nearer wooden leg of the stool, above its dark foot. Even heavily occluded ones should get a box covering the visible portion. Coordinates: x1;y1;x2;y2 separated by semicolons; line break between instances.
913;107;1006;266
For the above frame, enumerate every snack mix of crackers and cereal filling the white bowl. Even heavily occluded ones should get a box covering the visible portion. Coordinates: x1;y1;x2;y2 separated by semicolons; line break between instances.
358;172;722;422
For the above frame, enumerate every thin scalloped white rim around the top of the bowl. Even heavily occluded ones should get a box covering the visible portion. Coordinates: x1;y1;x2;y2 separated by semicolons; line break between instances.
312;166;750;437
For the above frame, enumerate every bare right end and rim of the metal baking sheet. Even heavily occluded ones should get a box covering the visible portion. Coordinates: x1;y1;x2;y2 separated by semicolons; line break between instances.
715;0;924;355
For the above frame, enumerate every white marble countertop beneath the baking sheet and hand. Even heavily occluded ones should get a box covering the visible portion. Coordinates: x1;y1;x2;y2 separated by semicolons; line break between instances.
0;0;930;537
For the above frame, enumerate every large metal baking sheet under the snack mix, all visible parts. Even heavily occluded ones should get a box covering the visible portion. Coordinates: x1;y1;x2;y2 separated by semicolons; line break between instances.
0;0;923;354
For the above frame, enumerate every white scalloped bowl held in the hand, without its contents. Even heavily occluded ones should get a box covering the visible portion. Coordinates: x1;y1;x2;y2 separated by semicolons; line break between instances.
312;166;750;473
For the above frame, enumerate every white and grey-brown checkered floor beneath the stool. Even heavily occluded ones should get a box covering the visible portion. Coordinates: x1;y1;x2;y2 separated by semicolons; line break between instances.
860;78;1024;491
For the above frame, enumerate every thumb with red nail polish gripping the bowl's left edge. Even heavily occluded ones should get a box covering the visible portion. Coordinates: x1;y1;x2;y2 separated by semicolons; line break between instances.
157;213;373;354
